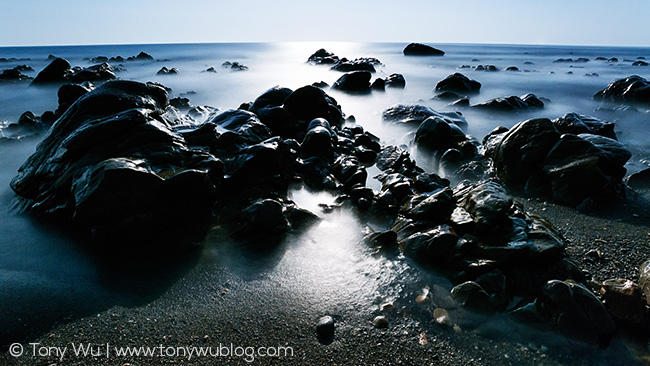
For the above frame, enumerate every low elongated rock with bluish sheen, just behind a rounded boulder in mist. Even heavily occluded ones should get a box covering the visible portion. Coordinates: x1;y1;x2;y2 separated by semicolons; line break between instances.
381;104;467;129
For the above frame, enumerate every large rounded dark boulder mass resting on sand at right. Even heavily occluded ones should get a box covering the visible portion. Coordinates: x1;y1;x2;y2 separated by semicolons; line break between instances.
484;116;631;206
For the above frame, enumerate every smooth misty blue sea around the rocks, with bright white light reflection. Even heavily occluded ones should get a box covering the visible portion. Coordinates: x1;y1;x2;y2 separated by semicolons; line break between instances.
0;43;650;360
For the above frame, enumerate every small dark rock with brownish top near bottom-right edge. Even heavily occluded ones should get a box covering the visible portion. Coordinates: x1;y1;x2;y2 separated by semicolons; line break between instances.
600;278;645;324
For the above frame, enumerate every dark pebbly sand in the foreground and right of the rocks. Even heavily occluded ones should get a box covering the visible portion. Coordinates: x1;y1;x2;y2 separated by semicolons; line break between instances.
0;190;650;365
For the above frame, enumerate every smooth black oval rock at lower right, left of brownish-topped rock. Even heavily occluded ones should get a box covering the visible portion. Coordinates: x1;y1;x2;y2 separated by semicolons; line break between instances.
537;280;615;347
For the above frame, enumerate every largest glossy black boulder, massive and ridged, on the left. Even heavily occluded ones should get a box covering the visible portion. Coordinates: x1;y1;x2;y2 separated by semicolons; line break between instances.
11;81;223;251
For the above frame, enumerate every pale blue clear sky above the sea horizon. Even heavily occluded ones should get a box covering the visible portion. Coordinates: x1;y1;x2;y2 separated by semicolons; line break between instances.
0;0;650;46
